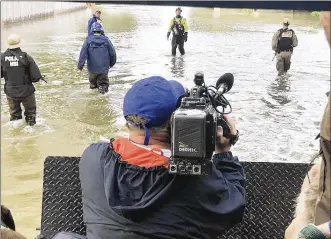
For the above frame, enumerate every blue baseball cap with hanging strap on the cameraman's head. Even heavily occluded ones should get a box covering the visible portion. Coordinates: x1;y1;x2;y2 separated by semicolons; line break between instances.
123;76;185;145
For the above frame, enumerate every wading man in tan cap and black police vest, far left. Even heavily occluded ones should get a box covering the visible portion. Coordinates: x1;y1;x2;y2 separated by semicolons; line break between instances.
1;34;43;126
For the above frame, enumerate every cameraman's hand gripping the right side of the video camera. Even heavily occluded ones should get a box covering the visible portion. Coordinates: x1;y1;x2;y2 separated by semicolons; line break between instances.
215;116;237;153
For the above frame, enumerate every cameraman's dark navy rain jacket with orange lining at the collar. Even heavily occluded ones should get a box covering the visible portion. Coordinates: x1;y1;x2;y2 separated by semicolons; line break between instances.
79;139;245;239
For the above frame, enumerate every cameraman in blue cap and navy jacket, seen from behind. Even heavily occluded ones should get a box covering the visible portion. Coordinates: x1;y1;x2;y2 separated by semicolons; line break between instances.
79;76;245;239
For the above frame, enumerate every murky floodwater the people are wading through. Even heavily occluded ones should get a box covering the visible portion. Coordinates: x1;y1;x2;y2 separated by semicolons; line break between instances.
1;5;330;238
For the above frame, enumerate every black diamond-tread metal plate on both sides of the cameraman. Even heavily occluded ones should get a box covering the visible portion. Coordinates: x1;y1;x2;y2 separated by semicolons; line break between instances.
41;157;308;239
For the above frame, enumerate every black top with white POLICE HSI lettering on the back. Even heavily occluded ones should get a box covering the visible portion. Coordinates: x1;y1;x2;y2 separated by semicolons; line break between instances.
1;48;42;98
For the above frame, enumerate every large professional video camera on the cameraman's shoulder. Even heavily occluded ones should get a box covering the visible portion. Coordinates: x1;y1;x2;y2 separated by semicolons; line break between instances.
168;72;238;175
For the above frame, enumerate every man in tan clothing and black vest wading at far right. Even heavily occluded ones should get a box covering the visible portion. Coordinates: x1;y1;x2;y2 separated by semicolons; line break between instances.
271;18;298;76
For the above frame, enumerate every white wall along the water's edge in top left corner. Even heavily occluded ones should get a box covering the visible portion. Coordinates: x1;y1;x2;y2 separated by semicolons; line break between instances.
1;1;86;22
